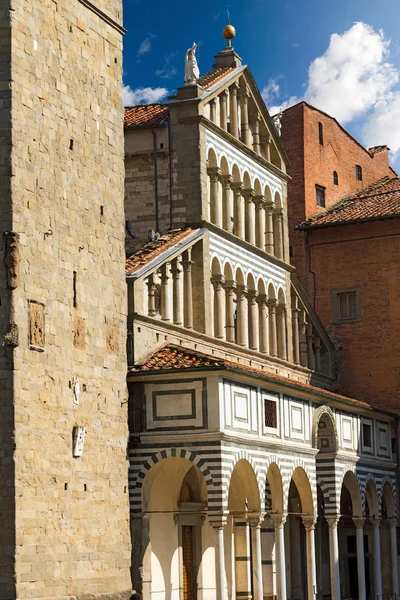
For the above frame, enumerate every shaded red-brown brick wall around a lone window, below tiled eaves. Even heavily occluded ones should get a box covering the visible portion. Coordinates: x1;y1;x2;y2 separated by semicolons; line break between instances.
306;219;400;409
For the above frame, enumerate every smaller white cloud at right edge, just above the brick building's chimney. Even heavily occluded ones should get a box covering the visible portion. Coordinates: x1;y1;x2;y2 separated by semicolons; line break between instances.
363;91;400;160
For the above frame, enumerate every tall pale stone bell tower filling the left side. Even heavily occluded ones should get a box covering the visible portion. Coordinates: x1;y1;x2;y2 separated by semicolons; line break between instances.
0;0;131;600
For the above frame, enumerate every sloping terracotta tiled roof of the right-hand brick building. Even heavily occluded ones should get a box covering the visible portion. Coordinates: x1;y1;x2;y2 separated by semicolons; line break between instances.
298;177;400;229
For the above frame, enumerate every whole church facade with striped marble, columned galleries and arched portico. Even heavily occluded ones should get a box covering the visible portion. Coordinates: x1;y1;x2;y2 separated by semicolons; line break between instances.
125;29;399;600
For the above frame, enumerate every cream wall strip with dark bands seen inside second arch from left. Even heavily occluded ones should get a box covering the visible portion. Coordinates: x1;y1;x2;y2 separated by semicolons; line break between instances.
234;516;252;600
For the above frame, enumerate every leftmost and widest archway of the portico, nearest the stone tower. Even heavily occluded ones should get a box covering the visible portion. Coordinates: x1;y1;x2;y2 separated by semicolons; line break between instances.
137;457;211;600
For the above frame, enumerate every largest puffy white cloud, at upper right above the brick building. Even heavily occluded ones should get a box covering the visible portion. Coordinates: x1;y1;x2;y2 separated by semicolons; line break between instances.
304;23;399;124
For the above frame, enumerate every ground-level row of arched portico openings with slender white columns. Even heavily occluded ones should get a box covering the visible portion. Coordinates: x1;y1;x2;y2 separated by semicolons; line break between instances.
134;436;399;600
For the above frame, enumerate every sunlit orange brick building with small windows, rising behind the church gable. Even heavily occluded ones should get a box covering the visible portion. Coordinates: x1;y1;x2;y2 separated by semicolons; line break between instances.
281;103;393;284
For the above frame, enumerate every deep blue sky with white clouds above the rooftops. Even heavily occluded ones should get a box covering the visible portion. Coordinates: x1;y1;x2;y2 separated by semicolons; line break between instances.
124;0;400;171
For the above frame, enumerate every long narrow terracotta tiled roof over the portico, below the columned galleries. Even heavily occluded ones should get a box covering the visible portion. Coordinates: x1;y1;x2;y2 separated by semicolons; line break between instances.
129;344;380;408
